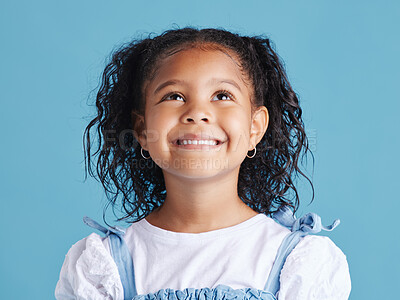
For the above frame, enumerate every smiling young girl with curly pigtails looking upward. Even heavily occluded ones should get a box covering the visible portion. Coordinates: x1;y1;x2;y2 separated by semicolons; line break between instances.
55;28;350;300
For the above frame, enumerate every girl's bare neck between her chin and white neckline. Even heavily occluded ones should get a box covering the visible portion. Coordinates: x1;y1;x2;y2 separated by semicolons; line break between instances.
146;170;258;233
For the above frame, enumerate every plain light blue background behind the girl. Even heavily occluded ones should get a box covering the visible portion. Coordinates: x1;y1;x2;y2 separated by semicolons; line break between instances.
0;0;400;300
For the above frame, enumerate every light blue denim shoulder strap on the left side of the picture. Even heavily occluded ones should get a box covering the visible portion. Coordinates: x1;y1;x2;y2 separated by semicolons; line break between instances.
83;217;137;300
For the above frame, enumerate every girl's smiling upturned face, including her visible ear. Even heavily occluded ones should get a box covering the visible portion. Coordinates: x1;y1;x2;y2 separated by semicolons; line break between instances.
135;48;268;179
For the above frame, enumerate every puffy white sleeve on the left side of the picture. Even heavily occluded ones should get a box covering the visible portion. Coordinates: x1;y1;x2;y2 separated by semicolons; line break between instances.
55;233;124;300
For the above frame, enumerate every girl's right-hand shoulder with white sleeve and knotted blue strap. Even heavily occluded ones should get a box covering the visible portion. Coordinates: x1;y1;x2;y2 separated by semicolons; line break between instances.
266;207;351;300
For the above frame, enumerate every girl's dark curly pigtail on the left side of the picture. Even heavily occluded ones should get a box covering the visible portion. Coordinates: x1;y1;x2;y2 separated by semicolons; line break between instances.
83;39;165;223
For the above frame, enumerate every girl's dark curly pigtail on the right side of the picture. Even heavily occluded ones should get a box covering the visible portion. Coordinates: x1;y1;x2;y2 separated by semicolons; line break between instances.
239;37;314;213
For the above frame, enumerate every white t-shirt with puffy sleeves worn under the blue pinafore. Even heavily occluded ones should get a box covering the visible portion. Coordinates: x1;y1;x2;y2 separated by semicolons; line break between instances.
55;214;351;300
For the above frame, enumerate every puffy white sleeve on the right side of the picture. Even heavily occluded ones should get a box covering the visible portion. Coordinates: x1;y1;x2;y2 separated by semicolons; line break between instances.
278;235;351;300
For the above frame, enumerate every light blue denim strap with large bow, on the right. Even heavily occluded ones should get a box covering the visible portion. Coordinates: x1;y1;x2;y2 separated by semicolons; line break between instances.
264;206;340;295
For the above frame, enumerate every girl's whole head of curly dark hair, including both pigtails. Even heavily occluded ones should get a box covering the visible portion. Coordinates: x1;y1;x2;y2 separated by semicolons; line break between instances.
83;27;314;222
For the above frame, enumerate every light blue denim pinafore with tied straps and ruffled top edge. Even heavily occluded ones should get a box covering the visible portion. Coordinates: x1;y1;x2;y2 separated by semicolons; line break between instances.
83;207;340;300
